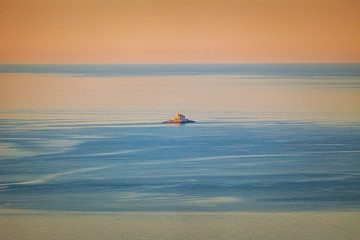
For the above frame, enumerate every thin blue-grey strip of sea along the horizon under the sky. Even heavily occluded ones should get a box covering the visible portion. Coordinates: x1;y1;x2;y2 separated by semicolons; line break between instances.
0;63;360;78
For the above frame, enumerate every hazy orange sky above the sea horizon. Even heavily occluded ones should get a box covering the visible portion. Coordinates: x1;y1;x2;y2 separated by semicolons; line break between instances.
0;0;360;63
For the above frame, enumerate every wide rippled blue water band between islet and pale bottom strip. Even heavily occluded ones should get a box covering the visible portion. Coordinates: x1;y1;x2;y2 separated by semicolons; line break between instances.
0;108;360;211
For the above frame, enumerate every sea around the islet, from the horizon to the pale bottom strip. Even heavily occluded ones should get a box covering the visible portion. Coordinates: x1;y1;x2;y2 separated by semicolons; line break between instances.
0;64;360;212
